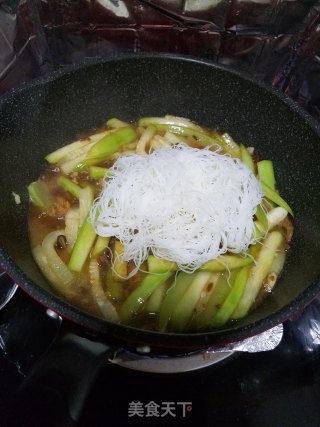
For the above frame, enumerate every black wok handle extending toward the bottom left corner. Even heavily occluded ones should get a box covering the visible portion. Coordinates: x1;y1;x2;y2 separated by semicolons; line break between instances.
9;326;120;427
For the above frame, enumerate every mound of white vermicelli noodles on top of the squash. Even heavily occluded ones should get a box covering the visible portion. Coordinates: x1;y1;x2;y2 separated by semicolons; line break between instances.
91;143;263;278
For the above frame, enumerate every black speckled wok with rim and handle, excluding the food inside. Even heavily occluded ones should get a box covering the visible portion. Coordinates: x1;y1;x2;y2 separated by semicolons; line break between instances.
0;54;320;426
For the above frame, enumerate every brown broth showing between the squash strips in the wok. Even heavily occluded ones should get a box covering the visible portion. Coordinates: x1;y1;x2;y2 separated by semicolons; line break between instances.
29;120;292;330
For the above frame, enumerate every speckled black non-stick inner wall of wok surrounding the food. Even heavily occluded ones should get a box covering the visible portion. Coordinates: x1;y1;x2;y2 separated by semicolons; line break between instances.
0;55;320;342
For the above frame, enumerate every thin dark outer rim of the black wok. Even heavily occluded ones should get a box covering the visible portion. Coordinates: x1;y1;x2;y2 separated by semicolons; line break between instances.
0;53;320;349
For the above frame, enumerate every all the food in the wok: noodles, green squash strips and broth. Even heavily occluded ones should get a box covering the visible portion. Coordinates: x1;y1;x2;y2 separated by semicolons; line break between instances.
28;115;293;333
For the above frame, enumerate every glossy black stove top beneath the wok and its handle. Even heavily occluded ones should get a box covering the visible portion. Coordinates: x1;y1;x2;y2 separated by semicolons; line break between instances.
0;270;320;427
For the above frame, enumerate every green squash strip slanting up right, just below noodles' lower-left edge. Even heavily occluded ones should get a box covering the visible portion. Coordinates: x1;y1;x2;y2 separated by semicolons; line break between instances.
120;272;172;323
